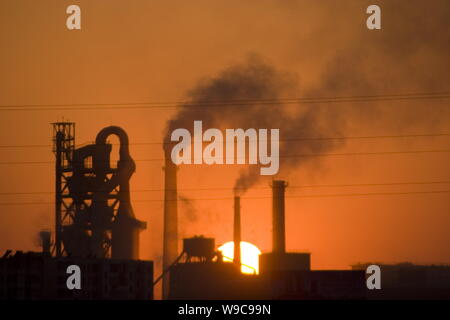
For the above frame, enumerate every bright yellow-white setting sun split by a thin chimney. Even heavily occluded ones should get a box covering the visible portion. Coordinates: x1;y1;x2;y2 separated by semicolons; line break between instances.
219;241;261;274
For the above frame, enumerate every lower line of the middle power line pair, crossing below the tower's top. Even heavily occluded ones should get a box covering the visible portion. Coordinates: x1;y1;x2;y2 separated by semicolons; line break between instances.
0;149;450;165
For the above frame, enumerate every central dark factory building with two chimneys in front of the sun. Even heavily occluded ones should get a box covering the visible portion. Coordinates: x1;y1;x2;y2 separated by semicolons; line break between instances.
163;180;366;299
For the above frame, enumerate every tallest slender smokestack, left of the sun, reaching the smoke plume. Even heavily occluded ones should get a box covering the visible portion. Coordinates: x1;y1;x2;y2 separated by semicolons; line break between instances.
162;152;178;299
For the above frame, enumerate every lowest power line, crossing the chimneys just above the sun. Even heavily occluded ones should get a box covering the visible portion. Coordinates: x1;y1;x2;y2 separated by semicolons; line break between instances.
0;190;450;206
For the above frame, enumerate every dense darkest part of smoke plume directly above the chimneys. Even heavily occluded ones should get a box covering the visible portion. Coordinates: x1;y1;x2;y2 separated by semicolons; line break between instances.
165;56;339;194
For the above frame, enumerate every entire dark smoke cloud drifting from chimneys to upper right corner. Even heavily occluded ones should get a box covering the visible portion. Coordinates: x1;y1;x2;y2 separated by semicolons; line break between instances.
165;1;450;194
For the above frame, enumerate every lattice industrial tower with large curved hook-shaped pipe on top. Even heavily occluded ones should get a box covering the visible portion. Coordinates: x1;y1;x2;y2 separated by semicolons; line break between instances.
53;122;146;259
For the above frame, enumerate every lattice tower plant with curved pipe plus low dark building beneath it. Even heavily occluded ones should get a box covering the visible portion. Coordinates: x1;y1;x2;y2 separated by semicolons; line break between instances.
0;122;153;300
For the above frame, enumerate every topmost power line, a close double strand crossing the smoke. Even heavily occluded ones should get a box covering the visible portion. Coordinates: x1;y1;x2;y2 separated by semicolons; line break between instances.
0;92;450;111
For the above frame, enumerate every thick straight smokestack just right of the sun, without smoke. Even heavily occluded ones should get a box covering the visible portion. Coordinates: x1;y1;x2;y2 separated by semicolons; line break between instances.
272;180;287;253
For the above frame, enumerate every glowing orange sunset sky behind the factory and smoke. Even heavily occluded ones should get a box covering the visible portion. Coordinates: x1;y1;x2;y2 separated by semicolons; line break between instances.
0;0;450;292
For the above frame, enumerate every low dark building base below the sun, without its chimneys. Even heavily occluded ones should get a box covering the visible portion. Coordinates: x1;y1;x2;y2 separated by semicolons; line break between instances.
169;255;366;299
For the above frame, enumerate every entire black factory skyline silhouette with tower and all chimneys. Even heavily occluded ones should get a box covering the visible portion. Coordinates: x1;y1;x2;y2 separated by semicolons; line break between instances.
5;122;450;300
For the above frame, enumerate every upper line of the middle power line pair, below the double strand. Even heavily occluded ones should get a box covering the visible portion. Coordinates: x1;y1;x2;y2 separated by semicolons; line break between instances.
0;133;450;148
